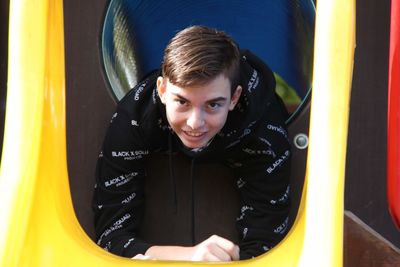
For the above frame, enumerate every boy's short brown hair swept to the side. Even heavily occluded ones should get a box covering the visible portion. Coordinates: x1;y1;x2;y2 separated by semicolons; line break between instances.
162;26;240;93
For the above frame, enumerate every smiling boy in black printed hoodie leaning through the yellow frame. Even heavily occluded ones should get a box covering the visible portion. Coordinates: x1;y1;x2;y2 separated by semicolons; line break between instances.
93;26;290;261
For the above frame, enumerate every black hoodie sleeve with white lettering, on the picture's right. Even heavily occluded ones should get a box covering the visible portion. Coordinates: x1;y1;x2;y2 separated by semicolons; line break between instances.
231;114;291;259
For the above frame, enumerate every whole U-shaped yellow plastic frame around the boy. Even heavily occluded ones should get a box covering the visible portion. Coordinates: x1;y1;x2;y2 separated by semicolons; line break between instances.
0;0;355;267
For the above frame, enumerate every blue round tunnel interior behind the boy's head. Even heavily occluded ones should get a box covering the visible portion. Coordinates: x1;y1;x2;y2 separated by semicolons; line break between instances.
102;0;315;121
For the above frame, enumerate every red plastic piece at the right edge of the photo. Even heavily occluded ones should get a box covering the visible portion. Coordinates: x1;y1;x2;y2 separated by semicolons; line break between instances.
387;0;400;229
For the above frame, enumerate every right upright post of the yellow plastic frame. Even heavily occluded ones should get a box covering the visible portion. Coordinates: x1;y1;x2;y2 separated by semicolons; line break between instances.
299;0;355;266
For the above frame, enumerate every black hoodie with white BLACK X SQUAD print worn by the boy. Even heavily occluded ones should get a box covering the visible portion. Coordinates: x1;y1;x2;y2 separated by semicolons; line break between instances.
93;51;291;259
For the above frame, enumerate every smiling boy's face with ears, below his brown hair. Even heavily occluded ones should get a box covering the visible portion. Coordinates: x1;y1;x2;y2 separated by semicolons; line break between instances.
157;74;242;148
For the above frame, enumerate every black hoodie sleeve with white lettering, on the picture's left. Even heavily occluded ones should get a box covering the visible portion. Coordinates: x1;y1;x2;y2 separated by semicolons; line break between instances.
92;109;151;257
